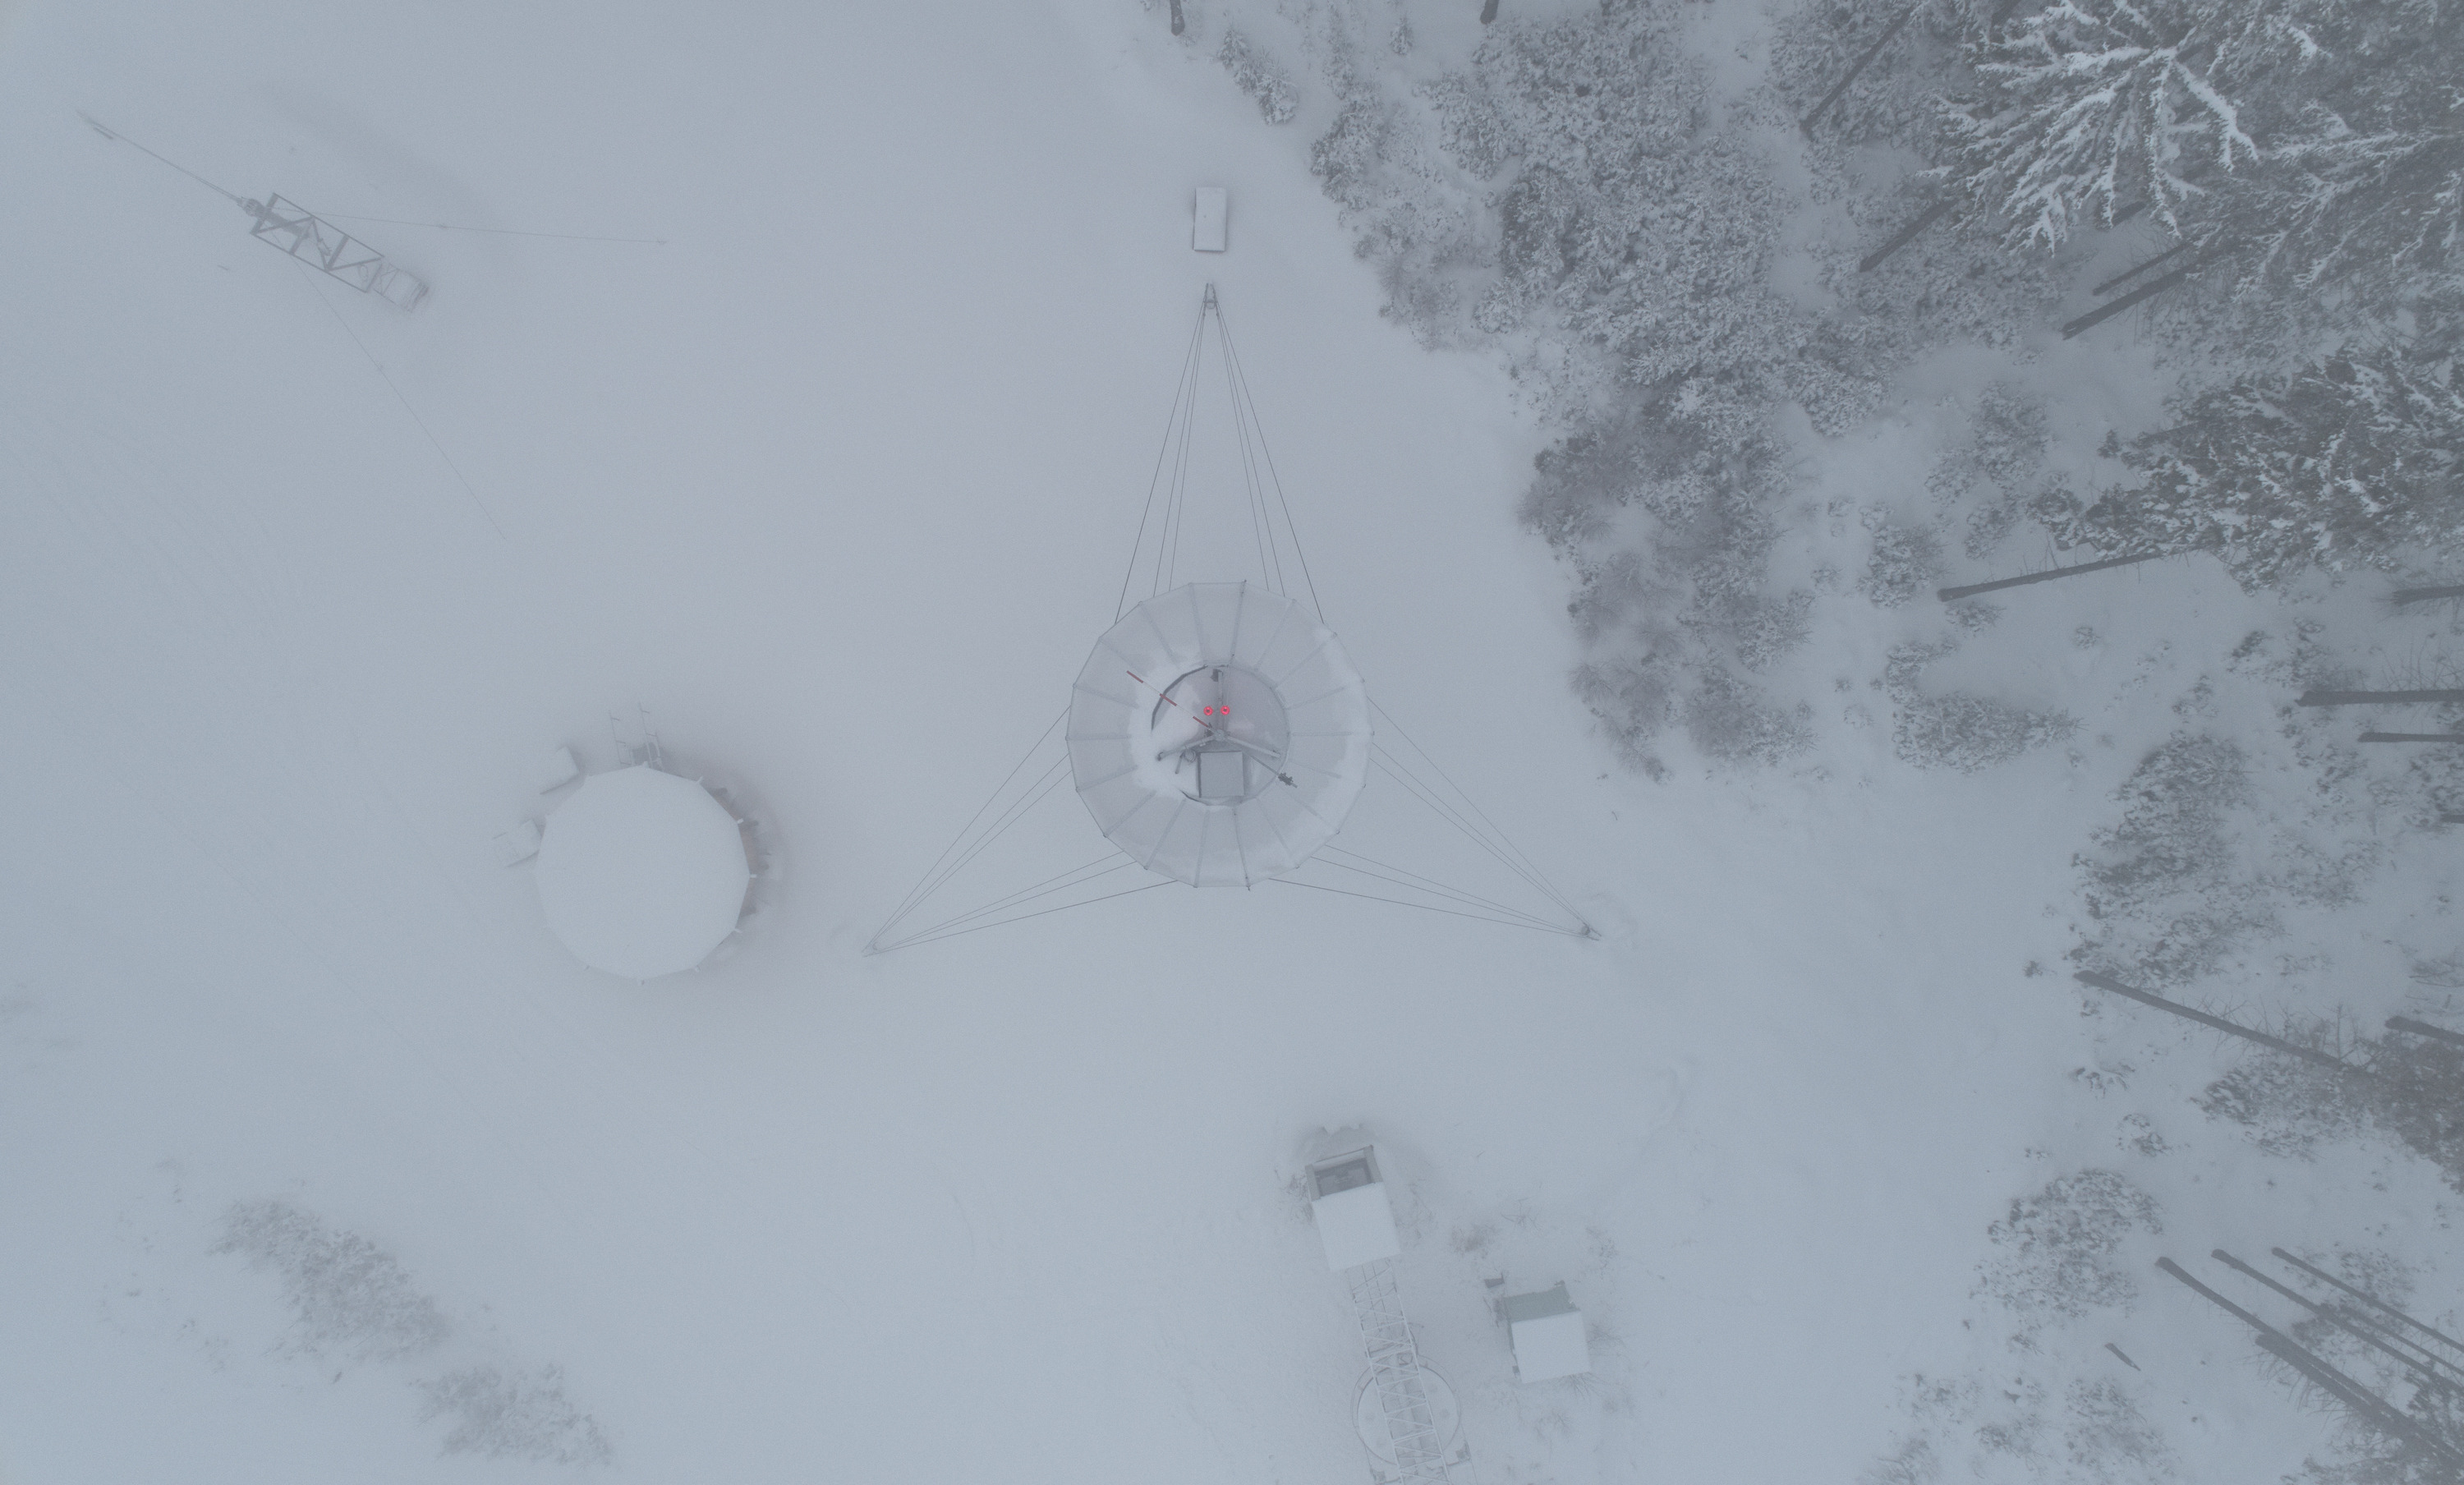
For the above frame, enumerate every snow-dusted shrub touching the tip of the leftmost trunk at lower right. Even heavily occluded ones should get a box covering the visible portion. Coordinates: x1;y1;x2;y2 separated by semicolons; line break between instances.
1984;1170;2163;1327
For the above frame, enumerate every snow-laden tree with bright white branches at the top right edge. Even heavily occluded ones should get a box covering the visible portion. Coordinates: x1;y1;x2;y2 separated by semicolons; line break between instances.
1947;0;2319;249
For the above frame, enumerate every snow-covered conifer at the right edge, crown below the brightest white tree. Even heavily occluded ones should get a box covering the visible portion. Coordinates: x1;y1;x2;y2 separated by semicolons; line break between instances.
2062;350;2464;589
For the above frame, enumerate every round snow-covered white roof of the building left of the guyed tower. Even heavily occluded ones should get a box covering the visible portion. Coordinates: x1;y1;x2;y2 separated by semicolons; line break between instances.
532;763;752;980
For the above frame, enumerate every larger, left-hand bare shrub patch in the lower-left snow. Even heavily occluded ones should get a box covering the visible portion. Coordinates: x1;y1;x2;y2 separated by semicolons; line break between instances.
212;1202;448;1359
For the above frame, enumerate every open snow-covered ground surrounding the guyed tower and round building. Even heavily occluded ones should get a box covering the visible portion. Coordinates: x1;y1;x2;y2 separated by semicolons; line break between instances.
0;0;2447;1485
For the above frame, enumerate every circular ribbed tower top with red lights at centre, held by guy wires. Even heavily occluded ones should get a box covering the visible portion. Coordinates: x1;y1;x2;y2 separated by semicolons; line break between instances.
1069;584;1370;886
